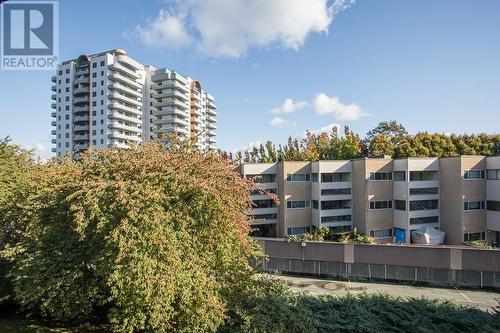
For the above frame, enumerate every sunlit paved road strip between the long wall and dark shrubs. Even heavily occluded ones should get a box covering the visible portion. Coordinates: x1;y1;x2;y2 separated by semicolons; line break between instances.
278;275;500;311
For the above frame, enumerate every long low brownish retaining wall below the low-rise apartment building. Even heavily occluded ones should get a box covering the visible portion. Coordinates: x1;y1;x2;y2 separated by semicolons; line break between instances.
257;238;500;289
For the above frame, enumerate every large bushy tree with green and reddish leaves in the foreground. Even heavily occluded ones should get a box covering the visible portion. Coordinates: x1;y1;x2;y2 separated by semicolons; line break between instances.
2;143;262;332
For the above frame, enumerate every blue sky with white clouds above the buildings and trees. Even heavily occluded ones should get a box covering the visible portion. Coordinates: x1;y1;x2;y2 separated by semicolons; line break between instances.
0;0;500;156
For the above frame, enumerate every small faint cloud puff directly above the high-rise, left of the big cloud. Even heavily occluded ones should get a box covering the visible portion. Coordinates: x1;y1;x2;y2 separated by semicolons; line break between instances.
137;10;191;49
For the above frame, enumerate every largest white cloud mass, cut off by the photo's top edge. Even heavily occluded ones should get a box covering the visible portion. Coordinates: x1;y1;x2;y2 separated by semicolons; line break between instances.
138;0;354;57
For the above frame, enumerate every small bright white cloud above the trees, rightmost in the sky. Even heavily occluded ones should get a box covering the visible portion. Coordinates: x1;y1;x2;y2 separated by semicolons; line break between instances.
313;93;368;120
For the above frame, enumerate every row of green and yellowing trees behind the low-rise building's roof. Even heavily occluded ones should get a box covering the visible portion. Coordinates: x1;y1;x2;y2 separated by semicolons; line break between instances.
231;121;500;163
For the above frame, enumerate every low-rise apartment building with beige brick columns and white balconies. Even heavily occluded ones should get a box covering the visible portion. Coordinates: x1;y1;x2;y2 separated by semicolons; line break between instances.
239;156;500;244
